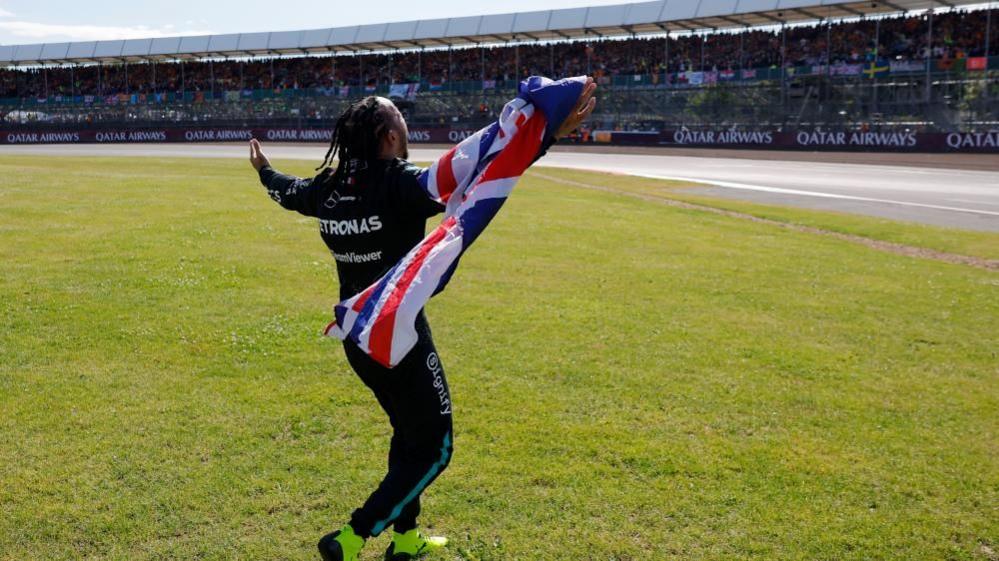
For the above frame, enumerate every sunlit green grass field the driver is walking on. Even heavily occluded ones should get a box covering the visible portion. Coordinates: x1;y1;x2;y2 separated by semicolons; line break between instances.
0;156;999;561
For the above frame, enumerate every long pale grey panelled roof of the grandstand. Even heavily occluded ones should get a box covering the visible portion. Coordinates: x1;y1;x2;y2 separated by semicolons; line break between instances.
0;0;981;66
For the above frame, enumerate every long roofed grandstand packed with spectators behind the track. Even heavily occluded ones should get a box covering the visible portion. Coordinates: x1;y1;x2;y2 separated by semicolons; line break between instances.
0;0;999;141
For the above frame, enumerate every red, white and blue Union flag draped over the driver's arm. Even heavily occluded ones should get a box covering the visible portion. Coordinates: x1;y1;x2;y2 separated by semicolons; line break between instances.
325;76;586;368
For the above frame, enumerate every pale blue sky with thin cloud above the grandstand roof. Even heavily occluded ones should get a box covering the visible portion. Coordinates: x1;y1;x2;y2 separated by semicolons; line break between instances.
0;0;627;45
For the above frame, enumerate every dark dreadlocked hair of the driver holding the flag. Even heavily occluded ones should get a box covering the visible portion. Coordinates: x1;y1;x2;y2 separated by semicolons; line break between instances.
316;95;390;181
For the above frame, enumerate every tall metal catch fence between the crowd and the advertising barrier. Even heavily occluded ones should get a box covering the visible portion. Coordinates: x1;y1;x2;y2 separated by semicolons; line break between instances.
0;68;999;131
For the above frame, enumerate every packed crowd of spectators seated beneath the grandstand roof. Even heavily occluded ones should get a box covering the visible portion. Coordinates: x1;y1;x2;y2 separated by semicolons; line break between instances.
0;10;999;99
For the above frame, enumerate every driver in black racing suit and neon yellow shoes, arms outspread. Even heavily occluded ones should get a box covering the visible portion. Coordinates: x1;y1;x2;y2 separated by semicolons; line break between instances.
250;81;596;561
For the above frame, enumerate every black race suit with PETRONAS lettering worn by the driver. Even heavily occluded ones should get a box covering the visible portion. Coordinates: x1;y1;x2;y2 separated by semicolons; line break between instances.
260;159;452;538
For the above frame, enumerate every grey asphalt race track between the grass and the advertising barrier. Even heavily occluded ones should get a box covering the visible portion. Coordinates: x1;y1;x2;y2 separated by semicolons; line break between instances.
7;142;999;232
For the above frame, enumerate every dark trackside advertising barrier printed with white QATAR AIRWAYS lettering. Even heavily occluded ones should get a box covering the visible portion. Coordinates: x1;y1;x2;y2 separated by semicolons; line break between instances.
0;127;999;154
